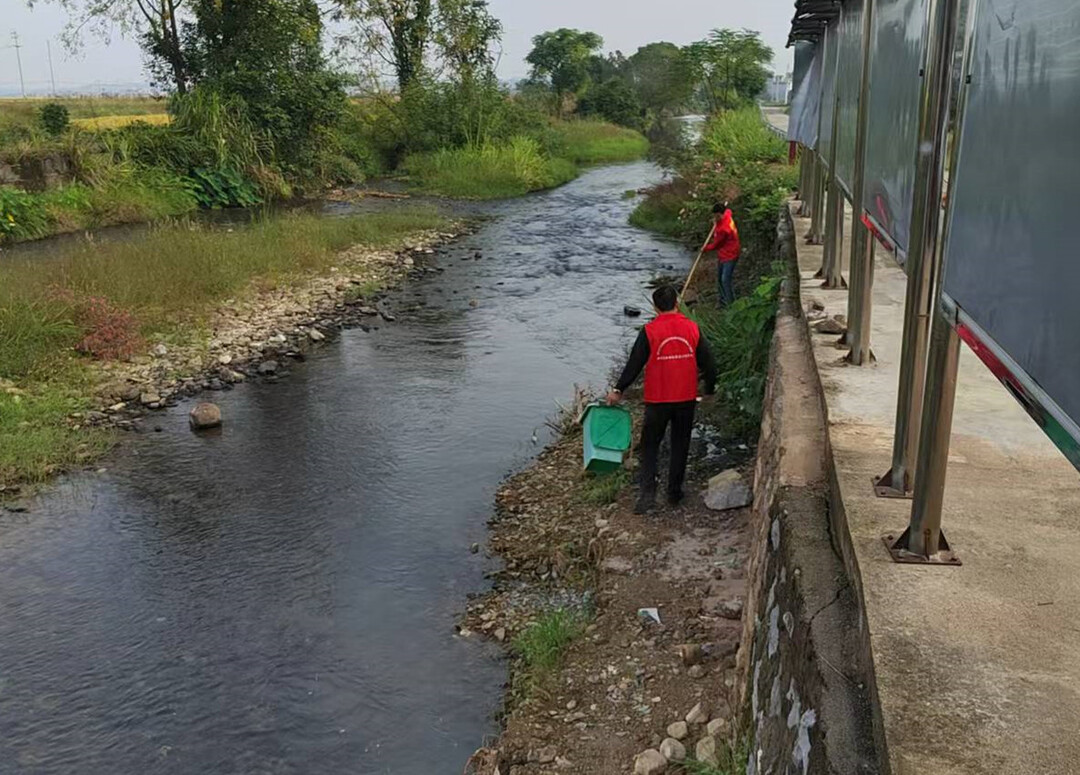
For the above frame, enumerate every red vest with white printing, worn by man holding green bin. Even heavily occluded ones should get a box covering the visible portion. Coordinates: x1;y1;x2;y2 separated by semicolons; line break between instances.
645;312;701;404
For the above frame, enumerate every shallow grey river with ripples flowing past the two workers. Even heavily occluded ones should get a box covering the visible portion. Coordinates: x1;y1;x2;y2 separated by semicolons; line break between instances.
0;162;689;775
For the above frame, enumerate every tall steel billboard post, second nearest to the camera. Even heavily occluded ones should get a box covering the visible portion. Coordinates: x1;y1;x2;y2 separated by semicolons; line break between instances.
874;0;960;498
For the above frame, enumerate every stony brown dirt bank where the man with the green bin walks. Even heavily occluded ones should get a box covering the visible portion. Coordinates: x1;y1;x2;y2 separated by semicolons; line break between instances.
461;407;750;775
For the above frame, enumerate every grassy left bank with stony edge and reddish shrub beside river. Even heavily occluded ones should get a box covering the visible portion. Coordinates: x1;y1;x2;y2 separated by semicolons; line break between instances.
0;208;462;497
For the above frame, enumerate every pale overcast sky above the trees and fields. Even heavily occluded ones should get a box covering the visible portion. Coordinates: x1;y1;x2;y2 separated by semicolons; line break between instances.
0;0;794;95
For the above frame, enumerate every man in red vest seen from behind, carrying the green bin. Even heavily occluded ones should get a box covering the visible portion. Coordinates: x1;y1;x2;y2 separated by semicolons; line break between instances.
607;285;716;514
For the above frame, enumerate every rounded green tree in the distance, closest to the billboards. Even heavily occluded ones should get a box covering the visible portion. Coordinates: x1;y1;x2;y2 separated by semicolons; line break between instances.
686;29;772;112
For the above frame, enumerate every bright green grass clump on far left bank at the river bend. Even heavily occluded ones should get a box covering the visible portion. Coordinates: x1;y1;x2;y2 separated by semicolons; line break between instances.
405;136;577;199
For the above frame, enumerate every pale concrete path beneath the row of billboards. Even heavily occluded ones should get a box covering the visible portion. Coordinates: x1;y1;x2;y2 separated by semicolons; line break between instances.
785;201;1080;775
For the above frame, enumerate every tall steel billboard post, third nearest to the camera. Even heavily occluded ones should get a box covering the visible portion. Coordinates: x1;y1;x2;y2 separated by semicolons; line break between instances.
845;0;876;366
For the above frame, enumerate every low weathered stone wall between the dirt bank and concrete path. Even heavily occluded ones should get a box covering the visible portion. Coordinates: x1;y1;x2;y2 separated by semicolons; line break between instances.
735;209;888;775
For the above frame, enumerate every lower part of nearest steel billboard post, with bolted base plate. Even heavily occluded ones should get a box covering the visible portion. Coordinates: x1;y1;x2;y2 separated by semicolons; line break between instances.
885;303;961;566
